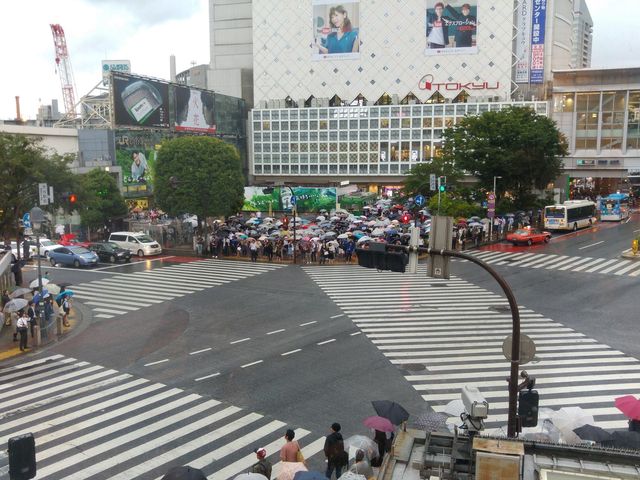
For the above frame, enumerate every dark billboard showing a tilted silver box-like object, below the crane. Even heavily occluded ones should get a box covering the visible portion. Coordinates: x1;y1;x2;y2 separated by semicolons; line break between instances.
111;73;169;128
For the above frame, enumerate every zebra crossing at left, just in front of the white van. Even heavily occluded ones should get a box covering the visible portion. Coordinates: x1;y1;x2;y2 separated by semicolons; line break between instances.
71;260;283;318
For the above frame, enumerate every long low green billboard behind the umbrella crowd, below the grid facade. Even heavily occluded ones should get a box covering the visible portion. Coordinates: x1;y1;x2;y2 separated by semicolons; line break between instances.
242;187;336;213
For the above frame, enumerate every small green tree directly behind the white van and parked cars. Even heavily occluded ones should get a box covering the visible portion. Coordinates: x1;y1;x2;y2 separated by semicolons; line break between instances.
76;169;127;228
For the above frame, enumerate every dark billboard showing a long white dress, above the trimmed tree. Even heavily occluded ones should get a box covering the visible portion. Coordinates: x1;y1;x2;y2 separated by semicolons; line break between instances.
174;86;216;133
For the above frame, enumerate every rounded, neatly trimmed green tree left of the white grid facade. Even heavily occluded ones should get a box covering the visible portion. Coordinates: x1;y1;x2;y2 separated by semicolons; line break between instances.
154;137;244;218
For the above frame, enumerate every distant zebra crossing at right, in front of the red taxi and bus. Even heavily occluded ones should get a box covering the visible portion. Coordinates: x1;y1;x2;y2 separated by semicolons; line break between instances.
461;250;640;277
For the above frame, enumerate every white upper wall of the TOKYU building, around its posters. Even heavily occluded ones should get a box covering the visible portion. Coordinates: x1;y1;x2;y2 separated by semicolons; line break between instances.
253;0;513;105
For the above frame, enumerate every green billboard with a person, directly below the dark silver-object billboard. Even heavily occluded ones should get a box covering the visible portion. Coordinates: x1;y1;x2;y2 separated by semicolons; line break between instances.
115;130;168;198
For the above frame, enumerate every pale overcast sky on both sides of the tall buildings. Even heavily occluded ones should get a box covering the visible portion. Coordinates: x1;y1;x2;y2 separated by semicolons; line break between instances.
0;0;640;119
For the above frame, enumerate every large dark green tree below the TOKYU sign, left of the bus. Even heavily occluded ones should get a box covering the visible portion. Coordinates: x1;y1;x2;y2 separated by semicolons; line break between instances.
442;107;567;207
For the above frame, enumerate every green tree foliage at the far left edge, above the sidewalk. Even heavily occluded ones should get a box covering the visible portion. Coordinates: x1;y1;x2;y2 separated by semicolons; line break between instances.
0;134;78;239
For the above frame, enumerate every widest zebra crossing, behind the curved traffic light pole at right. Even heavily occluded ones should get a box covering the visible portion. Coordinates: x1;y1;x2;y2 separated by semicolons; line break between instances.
304;266;640;428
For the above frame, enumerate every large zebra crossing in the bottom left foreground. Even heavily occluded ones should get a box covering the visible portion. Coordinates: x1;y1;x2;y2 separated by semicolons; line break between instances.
0;355;325;480
